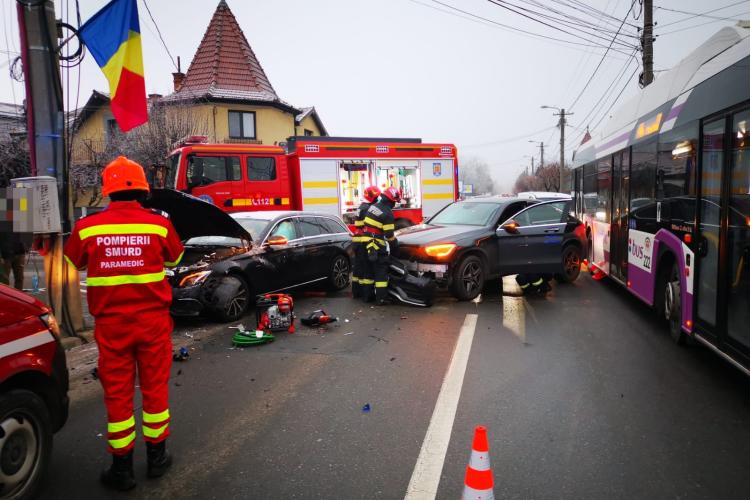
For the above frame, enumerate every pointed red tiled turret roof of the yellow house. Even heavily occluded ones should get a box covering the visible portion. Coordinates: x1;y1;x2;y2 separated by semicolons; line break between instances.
173;0;279;101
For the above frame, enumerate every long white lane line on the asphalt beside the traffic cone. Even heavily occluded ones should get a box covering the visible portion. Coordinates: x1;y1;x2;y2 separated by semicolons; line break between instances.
404;314;478;500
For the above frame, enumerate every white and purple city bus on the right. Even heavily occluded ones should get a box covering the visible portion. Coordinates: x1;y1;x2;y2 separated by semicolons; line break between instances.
571;23;750;375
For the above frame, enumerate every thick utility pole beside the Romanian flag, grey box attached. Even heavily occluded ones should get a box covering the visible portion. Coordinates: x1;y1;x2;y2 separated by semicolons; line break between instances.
16;0;83;336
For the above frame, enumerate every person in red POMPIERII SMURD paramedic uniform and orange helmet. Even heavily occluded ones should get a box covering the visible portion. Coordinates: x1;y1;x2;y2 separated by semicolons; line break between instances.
65;156;183;490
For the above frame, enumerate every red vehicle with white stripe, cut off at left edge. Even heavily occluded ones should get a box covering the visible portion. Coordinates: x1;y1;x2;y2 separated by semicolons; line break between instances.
0;285;68;498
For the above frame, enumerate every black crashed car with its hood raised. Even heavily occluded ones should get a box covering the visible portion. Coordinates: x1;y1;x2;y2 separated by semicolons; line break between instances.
147;190;353;321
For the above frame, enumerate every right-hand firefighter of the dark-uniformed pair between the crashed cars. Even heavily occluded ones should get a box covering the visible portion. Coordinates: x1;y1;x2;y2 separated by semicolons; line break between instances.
364;187;401;304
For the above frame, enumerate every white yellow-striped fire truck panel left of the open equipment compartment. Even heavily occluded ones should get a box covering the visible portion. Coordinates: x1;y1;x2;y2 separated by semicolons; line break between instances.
299;158;341;217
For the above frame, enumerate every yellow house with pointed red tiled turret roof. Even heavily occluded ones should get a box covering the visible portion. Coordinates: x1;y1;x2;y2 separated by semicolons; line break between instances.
70;0;328;204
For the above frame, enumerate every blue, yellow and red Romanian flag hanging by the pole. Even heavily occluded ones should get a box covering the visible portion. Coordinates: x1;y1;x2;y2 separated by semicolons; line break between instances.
80;0;148;132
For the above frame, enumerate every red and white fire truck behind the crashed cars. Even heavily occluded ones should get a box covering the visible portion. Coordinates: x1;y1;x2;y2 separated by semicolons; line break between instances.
165;136;459;227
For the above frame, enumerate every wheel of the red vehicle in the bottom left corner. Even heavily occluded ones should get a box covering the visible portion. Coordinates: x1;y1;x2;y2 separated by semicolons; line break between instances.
0;389;52;499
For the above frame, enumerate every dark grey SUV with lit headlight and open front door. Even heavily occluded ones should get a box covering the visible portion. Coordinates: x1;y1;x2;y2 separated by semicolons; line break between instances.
397;197;586;300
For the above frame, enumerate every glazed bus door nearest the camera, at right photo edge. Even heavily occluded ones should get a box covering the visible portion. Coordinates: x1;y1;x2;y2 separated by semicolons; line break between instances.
695;110;750;357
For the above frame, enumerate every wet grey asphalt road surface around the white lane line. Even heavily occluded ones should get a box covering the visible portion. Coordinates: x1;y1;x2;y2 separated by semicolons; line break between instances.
42;276;750;499
